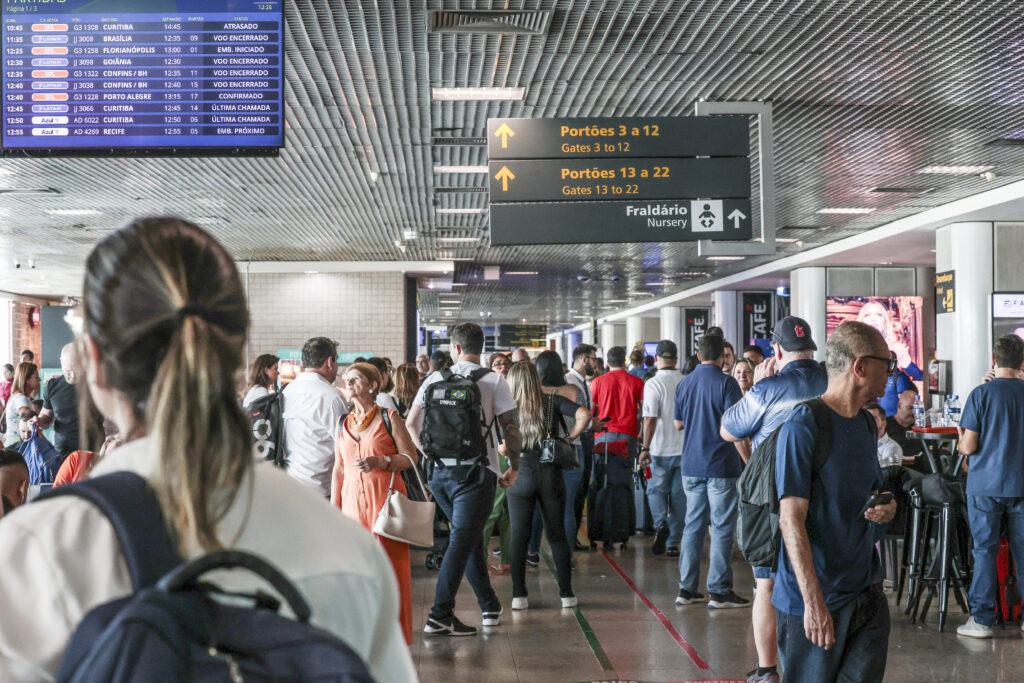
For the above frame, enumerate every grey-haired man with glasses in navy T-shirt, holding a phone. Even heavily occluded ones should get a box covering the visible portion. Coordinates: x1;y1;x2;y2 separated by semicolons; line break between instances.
772;322;896;683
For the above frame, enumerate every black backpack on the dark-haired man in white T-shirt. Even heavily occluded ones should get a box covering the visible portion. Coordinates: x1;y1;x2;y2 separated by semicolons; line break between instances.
420;368;494;481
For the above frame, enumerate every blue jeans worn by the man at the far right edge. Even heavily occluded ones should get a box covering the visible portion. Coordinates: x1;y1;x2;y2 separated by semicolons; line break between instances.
967;496;1024;626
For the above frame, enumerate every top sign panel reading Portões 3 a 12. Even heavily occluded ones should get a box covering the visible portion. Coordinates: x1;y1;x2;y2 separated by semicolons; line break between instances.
487;116;751;160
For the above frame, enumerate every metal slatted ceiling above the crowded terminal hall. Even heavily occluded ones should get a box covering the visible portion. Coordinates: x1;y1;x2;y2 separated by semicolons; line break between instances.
0;0;1024;324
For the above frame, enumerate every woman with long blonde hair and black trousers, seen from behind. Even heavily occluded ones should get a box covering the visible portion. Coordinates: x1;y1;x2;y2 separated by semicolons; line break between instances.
508;353;591;609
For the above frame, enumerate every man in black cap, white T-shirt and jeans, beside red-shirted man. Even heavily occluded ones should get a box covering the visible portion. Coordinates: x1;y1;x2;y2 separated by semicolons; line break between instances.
640;339;686;557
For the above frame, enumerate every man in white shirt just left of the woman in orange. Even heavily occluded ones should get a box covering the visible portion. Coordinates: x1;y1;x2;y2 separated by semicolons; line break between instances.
284;337;348;498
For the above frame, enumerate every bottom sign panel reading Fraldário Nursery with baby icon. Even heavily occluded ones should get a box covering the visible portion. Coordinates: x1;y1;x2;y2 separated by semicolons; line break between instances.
490;200;752;245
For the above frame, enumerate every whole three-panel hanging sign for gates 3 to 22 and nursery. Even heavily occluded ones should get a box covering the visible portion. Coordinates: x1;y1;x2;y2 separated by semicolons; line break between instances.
487;116;752;245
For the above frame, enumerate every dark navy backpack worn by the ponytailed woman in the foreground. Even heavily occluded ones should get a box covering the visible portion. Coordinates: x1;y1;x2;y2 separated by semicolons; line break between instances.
40;472;373;683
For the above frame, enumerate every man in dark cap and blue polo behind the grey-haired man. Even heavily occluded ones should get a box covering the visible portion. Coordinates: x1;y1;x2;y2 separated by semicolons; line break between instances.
721;315;828;683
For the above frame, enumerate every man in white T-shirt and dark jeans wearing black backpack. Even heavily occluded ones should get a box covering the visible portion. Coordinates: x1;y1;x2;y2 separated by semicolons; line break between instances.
406;323;521;636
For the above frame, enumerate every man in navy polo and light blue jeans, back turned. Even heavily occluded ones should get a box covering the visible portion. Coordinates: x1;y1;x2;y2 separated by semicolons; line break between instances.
675;335;751;609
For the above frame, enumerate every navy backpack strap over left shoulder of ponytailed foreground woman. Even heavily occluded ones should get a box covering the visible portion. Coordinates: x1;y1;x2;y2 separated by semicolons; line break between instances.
37;472;183;591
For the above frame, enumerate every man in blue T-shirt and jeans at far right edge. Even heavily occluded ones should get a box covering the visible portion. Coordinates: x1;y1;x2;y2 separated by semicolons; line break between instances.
956;335;1024;638
